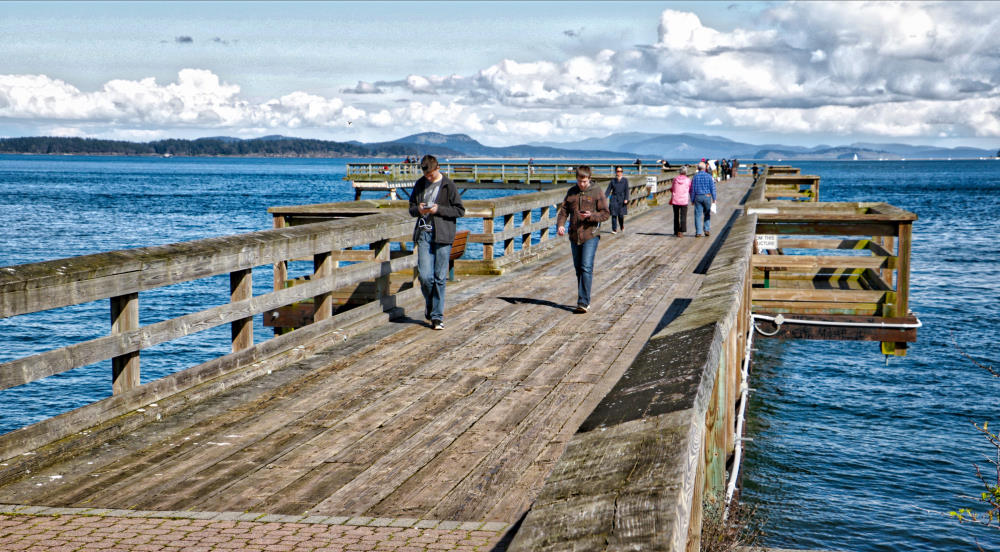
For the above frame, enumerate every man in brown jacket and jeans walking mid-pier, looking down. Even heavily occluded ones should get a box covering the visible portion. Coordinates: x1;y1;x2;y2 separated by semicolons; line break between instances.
556;165;611;313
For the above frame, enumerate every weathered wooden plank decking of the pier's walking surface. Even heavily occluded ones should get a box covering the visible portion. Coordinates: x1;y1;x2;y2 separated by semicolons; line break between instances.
0;177;750;523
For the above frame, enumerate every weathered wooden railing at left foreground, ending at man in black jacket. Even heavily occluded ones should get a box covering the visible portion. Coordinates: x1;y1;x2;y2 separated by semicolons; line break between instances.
0;212;419;458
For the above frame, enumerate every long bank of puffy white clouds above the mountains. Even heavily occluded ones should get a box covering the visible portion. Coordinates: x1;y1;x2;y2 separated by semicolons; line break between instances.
0;2;1000;144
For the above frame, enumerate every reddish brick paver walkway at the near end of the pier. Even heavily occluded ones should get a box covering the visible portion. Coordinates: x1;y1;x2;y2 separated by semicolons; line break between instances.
0;505;509;552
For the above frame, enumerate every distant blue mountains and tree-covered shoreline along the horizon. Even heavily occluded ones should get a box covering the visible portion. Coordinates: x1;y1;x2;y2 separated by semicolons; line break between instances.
0;132;1000;163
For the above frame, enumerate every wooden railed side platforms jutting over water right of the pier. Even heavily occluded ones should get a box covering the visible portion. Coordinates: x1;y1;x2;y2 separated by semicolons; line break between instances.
747;167;919;356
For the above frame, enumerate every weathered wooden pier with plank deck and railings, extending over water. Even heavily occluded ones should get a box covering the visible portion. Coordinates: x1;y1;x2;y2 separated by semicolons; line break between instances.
0;162;912;551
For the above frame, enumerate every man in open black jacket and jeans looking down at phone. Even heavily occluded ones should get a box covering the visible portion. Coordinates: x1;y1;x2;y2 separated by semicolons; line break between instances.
410;155;465;330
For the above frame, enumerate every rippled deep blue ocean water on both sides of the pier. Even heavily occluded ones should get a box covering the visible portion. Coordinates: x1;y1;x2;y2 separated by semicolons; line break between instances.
0;155;1000;551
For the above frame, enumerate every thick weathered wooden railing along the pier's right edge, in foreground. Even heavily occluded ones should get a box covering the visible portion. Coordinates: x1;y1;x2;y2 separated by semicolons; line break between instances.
509;215;756;552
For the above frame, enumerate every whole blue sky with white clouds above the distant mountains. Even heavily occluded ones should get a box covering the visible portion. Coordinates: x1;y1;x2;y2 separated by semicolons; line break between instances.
0;1;1000;149
